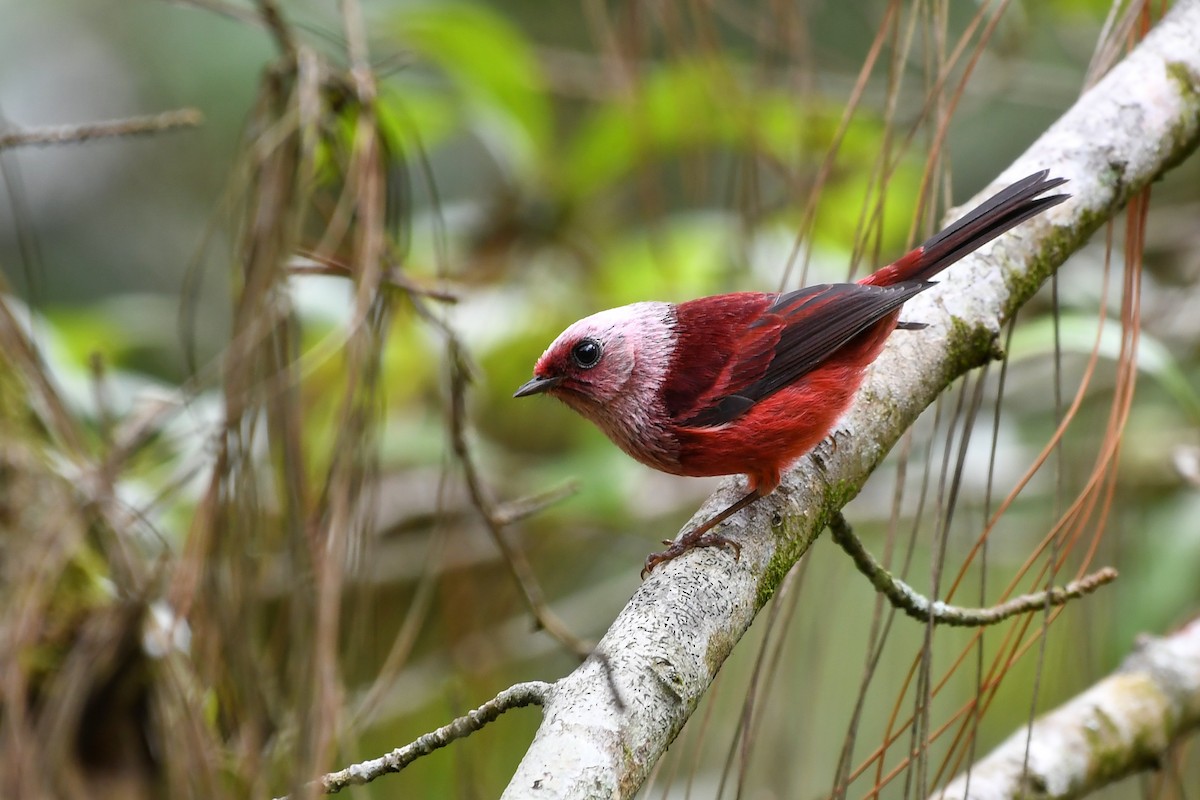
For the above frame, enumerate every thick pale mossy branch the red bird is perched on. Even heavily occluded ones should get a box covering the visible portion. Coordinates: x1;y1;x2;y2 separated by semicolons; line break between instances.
504;0;1200;800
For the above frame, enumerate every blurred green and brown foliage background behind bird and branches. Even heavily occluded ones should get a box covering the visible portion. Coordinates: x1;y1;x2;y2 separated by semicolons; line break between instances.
0;0;1200;799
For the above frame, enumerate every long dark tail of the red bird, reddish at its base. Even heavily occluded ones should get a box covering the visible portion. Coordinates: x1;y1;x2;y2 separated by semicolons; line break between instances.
859;169;1070;287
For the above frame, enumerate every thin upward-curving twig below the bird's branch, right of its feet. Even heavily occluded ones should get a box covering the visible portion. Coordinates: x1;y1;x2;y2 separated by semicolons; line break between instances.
829;512;1117;627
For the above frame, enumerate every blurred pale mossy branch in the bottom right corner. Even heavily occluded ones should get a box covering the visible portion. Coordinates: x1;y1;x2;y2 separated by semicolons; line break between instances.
931;620;1200;800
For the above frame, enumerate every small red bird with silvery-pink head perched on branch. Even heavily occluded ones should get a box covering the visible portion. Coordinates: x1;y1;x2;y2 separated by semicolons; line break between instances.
514;169;1070;578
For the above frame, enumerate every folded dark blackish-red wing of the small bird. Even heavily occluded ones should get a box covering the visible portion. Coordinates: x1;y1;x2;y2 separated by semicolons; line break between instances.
672;282;932;427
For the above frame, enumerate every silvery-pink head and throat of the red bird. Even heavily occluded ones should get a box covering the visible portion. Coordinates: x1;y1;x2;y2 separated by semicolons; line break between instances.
536;302;677;471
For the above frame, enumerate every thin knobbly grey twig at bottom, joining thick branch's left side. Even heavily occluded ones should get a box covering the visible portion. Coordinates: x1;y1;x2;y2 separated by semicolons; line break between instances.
277;680;552;800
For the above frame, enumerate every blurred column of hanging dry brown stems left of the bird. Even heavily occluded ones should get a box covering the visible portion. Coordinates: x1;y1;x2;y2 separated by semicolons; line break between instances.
158;2;408;793
